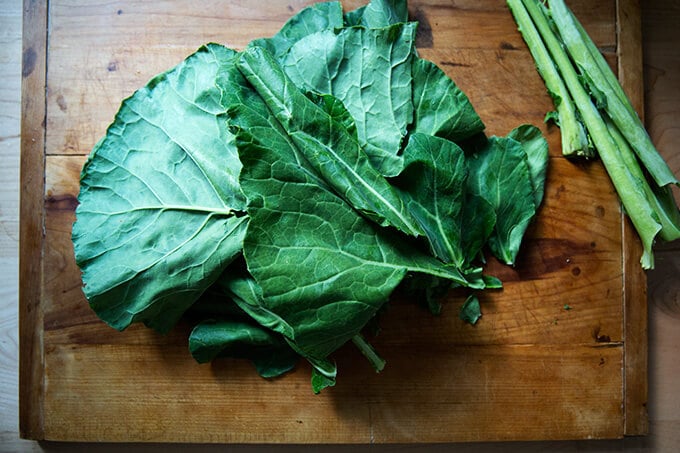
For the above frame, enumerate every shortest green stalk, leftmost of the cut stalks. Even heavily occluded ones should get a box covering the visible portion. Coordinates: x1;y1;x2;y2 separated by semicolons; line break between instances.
508;0;594;157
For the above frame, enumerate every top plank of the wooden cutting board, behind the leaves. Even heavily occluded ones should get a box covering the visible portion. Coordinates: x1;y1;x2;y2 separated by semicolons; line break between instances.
46;0;616;154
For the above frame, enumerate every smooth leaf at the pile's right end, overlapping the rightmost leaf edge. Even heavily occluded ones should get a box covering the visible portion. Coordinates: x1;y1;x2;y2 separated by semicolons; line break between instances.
468;137;536;265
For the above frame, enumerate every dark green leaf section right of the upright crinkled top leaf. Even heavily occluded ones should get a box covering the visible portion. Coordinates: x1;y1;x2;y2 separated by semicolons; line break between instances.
412;58;484;143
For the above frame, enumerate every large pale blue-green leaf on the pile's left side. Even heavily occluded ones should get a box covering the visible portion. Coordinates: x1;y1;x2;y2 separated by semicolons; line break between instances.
73;45;247;332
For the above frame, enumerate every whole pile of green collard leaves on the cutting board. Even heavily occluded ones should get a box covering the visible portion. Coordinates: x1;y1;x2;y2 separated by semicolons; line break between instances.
73;0;548;392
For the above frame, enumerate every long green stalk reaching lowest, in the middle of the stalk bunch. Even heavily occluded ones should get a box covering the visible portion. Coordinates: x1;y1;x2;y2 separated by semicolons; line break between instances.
523;0;661;269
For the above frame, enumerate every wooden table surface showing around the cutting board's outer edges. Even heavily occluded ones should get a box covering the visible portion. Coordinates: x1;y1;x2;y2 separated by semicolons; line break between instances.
0;0;680;451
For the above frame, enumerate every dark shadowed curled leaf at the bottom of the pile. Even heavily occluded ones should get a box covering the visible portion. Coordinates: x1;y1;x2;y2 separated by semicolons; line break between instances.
189;319;299;378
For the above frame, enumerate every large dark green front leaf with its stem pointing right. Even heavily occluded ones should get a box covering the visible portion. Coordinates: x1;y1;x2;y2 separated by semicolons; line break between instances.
230;49;483;359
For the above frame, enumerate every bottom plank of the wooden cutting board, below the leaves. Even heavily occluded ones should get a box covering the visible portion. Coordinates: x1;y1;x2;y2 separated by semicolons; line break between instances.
45;344;622;444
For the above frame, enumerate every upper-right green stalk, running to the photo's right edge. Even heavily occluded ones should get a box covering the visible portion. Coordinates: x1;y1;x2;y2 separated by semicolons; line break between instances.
548;0;678;187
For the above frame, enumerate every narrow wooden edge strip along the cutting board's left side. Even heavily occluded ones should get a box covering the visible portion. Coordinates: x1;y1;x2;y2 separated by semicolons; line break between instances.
19;0;47;439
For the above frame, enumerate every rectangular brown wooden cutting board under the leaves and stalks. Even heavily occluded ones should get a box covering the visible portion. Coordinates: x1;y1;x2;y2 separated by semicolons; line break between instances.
20;0;647;443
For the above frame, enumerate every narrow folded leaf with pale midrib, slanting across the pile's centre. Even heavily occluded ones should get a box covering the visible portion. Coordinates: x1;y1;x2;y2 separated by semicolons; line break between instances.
232;48;422;236
